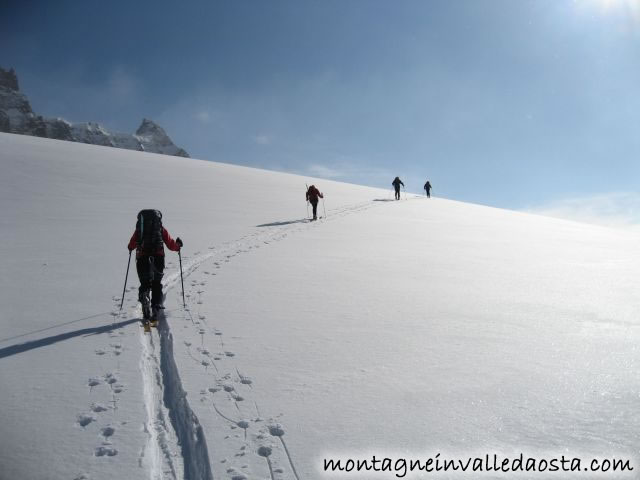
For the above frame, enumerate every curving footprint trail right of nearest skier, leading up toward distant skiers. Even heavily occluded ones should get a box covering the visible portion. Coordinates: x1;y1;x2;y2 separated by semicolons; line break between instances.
165;202;384;480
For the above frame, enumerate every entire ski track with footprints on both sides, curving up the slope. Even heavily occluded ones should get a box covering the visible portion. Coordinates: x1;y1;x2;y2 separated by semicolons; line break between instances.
102;197;419;480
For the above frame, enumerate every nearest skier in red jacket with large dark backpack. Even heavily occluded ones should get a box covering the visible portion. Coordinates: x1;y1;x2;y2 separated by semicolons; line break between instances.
127;210;183;330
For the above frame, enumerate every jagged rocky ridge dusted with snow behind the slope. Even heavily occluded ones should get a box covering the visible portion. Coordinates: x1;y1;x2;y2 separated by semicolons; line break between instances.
0;68;189;157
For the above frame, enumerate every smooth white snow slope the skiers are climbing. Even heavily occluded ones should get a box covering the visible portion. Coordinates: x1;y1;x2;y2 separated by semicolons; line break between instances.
0;134;640;480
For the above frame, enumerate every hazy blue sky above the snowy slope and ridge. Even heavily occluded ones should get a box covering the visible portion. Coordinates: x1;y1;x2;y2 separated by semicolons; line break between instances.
0;0;640;216
